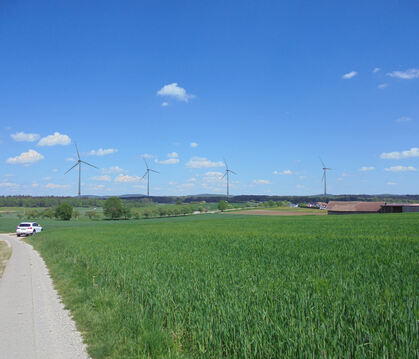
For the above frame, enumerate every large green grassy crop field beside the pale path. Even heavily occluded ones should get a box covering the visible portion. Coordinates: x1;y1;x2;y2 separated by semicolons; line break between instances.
27;214;419;358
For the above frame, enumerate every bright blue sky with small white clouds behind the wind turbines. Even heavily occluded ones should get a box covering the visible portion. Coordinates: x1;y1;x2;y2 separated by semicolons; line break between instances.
0;0;419;195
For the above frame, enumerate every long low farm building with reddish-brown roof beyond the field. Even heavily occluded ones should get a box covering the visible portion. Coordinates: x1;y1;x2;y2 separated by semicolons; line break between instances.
326;201;419;214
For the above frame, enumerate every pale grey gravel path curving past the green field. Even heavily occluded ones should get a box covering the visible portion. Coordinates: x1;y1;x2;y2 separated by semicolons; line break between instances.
0;234;88;359
